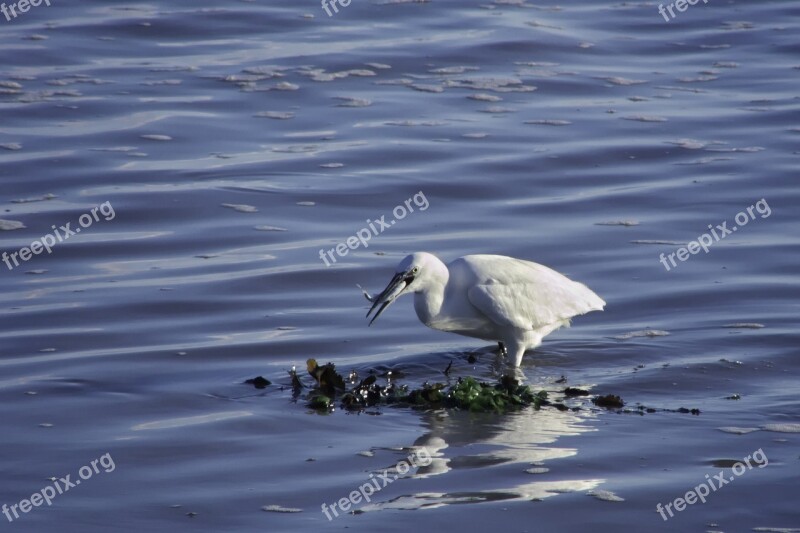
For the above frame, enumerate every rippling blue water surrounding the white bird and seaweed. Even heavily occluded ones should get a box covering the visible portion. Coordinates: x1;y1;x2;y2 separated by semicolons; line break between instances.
0;0;800;532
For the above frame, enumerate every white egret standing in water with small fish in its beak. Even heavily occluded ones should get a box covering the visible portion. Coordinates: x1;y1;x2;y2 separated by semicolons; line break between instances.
364;252;606;366
